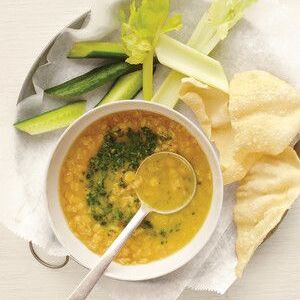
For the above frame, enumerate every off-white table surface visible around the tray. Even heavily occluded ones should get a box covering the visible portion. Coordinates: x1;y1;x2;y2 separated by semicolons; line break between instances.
0;0;300;300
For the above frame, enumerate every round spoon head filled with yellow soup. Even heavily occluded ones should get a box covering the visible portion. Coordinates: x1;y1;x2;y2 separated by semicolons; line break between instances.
136;152;196;213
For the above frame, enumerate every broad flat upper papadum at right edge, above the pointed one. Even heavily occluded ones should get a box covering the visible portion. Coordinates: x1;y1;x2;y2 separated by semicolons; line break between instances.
229;71;300;160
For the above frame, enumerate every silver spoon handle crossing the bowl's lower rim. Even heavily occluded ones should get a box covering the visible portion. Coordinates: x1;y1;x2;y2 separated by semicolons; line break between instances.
68;206;149;300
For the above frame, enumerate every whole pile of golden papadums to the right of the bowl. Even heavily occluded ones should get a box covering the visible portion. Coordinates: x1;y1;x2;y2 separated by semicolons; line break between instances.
180;71;300;277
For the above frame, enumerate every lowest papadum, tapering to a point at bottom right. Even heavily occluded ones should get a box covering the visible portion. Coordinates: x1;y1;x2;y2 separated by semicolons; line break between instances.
234;147;300;277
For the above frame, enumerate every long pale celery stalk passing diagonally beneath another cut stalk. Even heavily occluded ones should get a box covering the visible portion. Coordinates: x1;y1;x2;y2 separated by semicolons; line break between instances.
152;0;256;108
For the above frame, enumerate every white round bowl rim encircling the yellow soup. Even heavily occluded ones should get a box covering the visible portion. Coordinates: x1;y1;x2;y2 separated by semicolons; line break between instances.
46;100;223;281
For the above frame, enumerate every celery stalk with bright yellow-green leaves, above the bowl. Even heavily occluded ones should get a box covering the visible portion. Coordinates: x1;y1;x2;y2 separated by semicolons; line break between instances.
120;0;182;100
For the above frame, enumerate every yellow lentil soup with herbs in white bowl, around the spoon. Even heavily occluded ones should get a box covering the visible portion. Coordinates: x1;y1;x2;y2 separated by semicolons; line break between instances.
59;111;212;264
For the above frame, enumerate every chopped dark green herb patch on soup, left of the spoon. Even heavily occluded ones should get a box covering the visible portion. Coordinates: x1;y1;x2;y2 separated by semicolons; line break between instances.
84;127;159;228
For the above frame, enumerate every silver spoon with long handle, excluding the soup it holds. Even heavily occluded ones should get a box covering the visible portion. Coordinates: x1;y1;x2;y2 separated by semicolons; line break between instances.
68;152;196;300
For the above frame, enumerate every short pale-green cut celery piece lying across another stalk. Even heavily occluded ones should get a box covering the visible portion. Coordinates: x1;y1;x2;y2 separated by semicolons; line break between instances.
156;34;228;93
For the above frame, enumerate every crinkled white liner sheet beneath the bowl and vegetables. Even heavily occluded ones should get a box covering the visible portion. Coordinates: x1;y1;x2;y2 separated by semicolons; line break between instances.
0;0;300;300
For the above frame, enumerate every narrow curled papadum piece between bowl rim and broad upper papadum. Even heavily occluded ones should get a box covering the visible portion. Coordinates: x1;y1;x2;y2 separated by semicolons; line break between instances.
180;78;261;184
